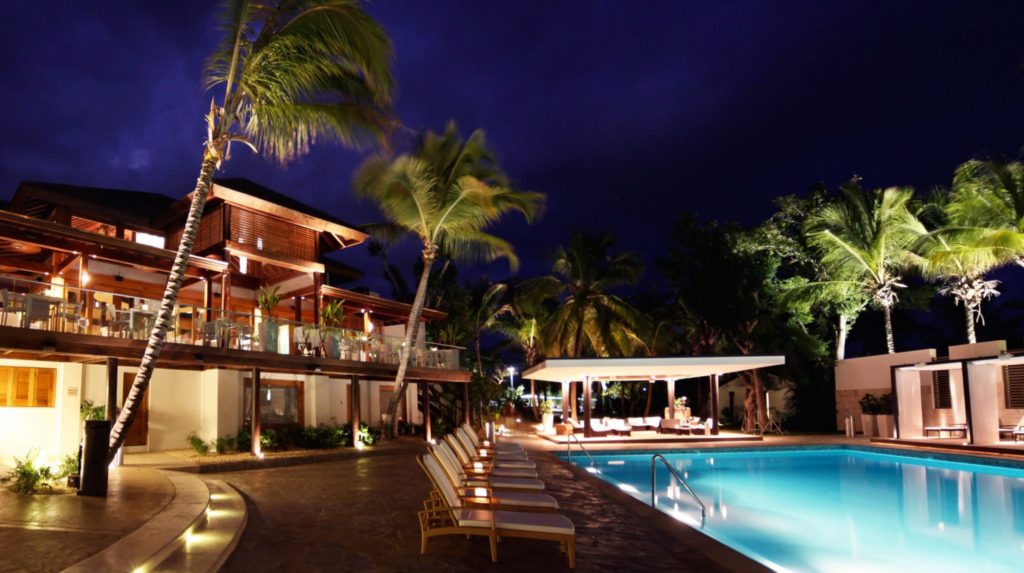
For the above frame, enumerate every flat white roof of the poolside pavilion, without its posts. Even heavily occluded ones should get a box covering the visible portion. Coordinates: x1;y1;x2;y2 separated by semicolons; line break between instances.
522;356;785;382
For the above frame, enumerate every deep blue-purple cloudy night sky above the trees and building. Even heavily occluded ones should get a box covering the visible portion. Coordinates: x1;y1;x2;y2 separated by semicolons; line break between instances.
0;0;1024;351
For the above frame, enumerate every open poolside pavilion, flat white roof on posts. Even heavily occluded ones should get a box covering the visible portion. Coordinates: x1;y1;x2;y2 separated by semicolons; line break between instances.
522;356;785;438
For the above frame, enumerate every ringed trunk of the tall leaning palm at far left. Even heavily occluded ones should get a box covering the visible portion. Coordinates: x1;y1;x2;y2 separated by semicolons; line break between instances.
106;152;217;462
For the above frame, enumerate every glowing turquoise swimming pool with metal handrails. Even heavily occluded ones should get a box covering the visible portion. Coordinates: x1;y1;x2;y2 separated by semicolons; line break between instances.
571;446;1024;573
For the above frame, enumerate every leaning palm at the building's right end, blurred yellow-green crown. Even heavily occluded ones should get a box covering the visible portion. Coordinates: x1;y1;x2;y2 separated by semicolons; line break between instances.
354;122;544;435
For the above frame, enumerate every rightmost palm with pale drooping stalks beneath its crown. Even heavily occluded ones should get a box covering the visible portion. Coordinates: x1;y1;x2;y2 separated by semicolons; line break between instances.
914;188;1024;344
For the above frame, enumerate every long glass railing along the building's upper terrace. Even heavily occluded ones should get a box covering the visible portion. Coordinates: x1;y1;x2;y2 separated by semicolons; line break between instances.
0;275;462;369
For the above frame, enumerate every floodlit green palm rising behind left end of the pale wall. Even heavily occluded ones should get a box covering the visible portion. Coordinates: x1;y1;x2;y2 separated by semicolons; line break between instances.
805;178;924;353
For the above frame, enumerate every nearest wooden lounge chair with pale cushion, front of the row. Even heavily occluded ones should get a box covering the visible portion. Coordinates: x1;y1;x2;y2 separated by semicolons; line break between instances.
418;455;575;569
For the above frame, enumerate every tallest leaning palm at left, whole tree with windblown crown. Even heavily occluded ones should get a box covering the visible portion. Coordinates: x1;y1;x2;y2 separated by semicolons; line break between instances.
109;0;393;459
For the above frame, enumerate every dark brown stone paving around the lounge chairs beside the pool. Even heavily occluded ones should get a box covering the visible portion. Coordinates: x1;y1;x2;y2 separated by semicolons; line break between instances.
211;437;724;573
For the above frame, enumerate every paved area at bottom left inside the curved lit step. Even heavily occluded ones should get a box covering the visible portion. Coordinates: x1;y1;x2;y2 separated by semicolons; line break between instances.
0;468;174;572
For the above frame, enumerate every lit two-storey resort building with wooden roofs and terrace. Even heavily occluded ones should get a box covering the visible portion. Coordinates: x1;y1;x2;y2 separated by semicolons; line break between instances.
0;179;469;459
